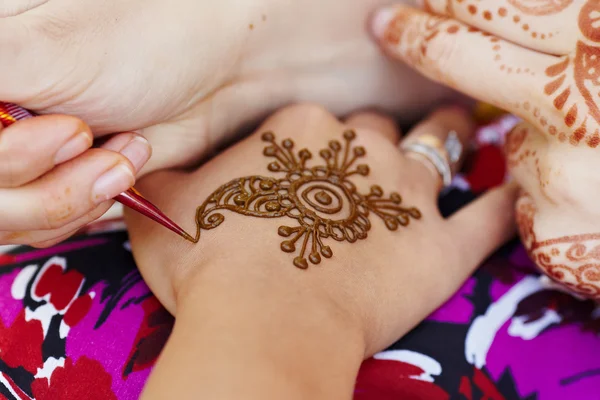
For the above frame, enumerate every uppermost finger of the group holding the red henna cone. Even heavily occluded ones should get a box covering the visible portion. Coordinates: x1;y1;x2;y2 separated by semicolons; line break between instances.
0;115;93;188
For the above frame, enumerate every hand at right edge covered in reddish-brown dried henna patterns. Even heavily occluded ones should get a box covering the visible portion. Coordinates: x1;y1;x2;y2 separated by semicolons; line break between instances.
373;0;600;299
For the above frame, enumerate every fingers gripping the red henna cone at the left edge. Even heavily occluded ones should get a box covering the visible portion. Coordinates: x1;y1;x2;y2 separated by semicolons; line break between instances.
0;115;151;247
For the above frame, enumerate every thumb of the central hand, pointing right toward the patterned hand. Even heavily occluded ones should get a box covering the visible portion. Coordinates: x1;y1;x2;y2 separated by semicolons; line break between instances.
448;182;519;273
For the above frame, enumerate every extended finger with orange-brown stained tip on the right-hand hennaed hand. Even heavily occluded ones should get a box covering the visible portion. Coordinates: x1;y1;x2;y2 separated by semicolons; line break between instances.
373;6;557;114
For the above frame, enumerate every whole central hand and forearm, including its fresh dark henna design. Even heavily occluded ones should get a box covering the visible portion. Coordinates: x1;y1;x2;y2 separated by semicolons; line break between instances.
127;105;516;399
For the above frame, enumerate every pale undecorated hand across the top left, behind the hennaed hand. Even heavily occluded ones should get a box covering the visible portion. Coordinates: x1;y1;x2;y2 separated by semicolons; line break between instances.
0;0;449;173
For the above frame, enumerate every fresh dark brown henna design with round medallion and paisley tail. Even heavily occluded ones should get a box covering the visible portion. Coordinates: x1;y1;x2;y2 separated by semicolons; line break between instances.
188;131;421;269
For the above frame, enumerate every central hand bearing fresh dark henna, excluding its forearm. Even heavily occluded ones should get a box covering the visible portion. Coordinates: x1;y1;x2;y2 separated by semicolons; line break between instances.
127;105;516;353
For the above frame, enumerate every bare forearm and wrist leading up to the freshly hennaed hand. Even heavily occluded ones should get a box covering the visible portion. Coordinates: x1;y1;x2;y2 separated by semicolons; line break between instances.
143;266;364;400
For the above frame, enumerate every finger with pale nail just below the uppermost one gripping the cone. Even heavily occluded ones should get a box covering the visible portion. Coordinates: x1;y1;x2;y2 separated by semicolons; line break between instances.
0;134;151;231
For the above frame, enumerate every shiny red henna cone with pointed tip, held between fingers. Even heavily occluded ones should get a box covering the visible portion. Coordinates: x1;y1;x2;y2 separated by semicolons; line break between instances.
0;101;194;242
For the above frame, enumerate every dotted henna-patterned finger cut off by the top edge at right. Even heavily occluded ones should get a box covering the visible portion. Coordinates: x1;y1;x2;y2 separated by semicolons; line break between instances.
414;0;580;55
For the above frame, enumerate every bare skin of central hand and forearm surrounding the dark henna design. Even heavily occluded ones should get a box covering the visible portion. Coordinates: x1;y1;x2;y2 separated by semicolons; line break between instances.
126;105;516;399
